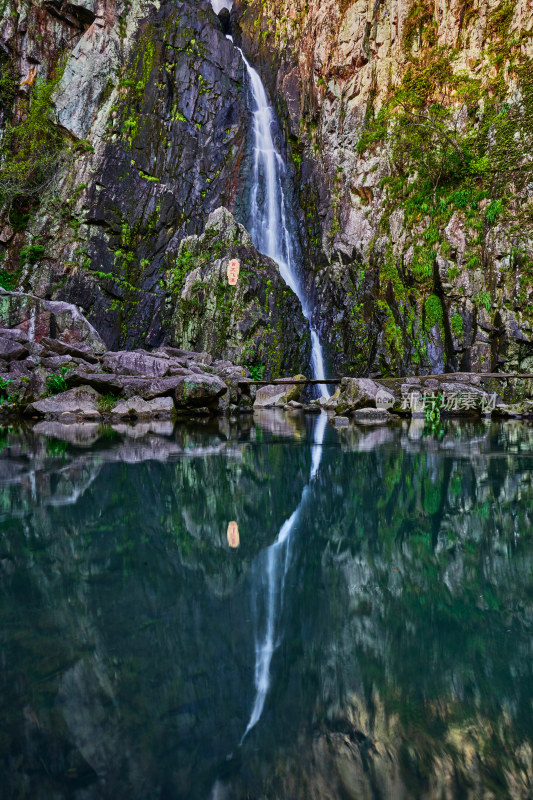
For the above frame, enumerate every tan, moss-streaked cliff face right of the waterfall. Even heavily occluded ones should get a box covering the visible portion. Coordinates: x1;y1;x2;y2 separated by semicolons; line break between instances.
234;0;533;374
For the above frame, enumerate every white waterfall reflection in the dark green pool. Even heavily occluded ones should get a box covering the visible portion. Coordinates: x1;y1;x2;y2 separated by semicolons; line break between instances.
239;412;327;745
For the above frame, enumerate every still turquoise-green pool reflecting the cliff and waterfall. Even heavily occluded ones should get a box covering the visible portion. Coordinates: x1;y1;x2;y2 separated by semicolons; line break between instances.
0;412;533;800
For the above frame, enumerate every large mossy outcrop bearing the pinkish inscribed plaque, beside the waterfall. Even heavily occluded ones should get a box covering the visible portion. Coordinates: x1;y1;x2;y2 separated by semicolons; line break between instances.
167;208;311;378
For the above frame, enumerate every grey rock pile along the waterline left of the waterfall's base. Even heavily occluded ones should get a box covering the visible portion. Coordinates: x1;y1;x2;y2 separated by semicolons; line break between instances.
0;292;255;421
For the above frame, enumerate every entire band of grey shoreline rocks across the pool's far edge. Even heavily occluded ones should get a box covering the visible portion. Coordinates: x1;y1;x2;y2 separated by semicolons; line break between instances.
0;290;533;427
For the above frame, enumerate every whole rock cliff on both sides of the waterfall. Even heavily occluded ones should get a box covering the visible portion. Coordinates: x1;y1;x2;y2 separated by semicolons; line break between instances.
0;0;533;375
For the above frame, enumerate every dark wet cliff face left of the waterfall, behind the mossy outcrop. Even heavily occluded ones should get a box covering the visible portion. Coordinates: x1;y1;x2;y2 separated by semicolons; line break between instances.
0;2;309;368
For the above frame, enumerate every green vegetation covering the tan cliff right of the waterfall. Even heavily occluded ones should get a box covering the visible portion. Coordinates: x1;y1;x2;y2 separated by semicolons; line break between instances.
358;2;533;368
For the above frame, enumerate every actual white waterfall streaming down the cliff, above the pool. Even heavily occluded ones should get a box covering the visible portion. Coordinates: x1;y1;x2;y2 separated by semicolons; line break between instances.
237;48;329;397
